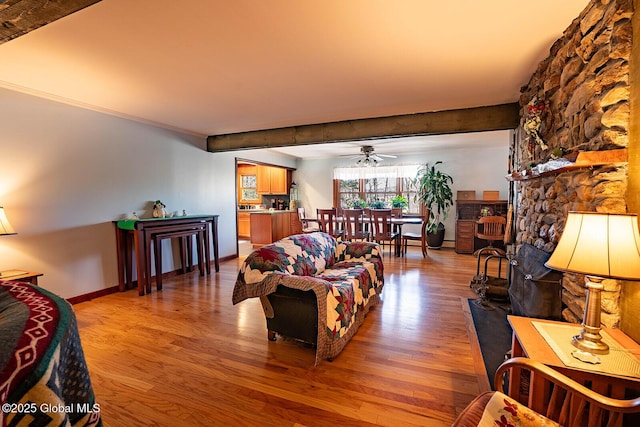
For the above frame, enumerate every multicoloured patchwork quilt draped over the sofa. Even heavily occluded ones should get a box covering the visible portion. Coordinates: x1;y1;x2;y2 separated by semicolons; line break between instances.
233;232;384;362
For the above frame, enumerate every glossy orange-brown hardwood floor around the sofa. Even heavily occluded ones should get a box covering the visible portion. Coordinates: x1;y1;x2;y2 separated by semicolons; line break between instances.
74;247;496;427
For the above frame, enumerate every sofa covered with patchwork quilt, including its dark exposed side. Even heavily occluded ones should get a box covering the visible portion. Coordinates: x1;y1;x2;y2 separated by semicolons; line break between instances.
233;232;384;364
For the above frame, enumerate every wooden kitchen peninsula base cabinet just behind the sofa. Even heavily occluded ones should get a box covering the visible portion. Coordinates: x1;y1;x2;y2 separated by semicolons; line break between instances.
250;211;302;248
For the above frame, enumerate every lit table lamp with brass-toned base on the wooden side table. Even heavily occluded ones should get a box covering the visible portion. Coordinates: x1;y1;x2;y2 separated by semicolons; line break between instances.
545;212;640;354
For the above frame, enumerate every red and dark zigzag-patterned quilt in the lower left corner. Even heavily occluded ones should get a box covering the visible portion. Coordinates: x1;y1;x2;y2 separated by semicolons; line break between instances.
0;281;102;427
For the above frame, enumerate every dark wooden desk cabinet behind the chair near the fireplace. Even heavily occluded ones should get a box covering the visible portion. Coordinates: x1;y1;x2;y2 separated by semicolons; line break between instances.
456;200;507;254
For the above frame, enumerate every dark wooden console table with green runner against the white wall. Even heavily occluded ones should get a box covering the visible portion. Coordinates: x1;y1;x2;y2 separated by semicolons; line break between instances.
114;215;220;295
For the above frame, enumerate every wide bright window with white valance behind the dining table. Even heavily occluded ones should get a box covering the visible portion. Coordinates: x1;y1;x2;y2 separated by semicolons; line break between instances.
333;165;421;214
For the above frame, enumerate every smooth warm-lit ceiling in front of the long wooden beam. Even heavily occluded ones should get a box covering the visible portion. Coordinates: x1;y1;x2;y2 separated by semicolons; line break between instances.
0;0;589;157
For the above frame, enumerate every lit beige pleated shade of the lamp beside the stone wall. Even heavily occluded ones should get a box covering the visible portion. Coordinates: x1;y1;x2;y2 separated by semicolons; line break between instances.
545;212;640;280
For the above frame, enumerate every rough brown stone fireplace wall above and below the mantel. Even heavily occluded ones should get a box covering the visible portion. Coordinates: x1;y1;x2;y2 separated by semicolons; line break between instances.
512;0;633;327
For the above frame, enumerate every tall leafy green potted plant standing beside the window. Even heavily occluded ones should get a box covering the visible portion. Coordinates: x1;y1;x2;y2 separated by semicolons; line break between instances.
414;161;453;249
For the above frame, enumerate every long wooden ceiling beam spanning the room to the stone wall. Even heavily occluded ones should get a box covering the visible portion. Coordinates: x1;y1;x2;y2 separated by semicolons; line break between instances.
207;103;520;153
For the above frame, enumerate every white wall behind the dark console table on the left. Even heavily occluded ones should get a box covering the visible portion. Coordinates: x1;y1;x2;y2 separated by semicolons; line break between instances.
0;89;295;297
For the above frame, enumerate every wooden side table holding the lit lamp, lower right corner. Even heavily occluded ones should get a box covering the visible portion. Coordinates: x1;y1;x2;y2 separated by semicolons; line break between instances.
507;316;640;413
